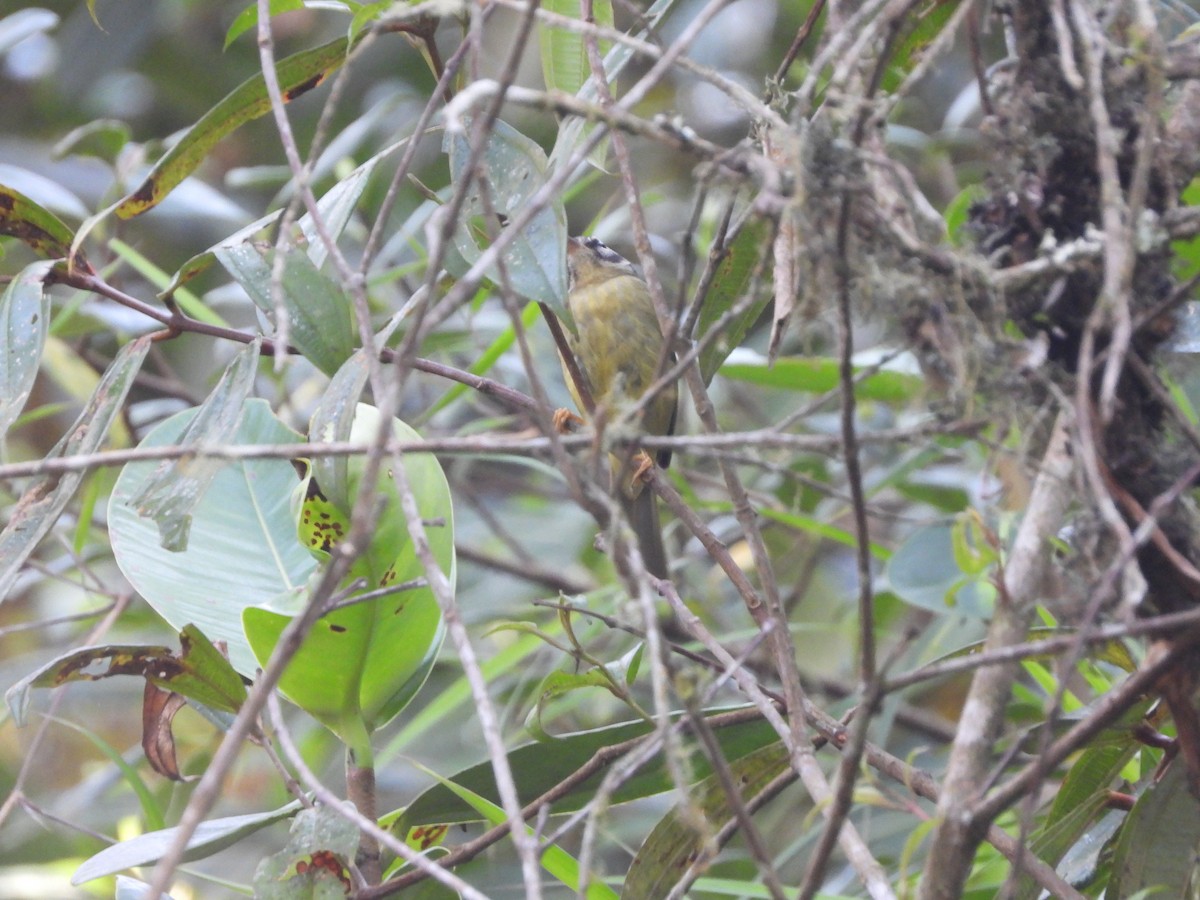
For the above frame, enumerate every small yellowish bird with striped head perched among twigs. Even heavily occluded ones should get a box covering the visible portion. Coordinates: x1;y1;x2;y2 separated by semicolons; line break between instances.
552;238;678;578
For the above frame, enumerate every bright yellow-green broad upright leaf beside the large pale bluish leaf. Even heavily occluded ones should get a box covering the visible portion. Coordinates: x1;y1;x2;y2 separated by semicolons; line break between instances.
242;404;455;745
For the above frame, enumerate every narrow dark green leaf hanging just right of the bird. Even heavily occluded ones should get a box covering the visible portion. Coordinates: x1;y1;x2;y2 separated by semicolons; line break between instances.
696;218;770;384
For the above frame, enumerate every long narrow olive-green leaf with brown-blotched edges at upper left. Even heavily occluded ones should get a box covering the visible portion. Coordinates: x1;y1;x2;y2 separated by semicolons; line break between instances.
114;37;350;218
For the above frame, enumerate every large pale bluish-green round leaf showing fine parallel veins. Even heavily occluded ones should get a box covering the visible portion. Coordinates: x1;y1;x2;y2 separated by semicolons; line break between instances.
108;400;316;677
